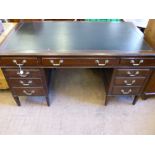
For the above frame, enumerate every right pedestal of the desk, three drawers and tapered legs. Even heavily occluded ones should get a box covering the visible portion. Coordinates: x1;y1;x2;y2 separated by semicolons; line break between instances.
104;68;151;105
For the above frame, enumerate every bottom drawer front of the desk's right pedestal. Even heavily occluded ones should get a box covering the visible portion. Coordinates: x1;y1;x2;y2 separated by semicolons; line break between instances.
112;86;141;95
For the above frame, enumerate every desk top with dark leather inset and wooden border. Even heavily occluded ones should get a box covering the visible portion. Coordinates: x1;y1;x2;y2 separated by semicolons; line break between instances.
0;22;155;55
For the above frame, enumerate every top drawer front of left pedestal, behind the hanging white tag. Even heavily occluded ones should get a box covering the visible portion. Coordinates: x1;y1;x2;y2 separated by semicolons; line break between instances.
5;69;41;78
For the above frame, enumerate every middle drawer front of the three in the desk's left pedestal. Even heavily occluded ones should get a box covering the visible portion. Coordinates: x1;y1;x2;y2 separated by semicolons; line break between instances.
9;78;43;87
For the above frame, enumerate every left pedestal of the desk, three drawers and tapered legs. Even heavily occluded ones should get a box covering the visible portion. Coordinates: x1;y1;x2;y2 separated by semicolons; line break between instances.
3;68;50;106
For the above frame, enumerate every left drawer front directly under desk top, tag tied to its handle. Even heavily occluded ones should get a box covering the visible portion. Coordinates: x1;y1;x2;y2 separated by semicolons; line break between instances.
1;57;38;66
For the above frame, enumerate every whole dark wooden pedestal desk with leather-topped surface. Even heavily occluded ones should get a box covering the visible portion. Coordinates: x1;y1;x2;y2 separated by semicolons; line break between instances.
0;22;155;106
